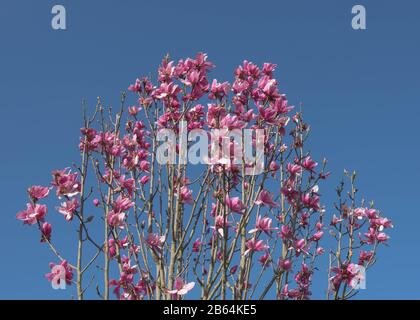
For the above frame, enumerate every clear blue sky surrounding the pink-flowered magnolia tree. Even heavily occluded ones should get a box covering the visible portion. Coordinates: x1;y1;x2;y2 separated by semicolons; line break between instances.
0;0;420;299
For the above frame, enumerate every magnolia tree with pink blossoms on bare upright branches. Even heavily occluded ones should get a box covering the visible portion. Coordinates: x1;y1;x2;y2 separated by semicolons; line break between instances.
17;53;392;300
